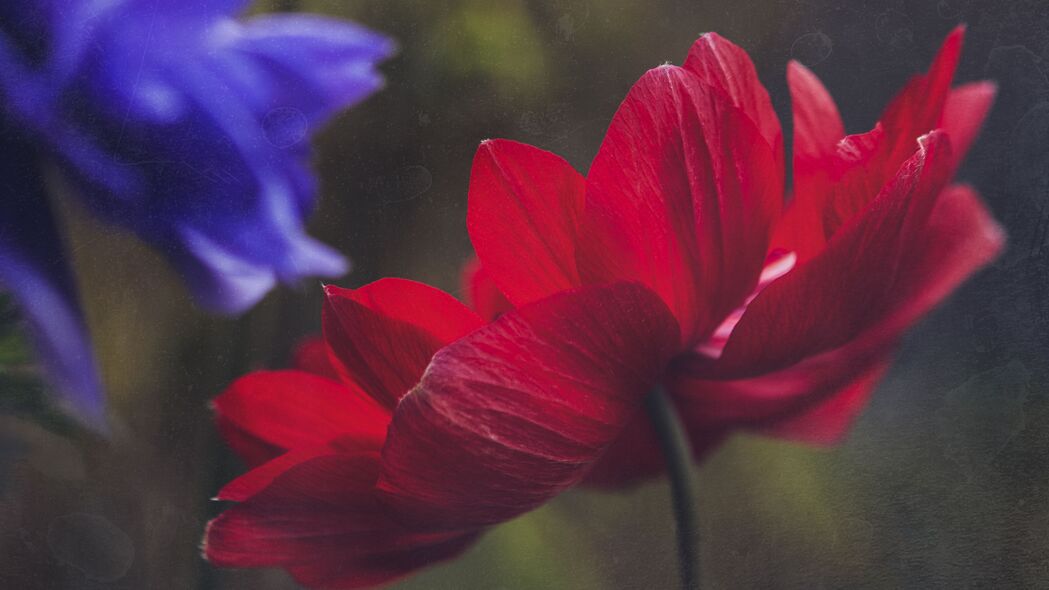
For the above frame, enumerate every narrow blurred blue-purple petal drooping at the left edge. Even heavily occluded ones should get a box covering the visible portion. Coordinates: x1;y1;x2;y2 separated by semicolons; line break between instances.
0;126;105;430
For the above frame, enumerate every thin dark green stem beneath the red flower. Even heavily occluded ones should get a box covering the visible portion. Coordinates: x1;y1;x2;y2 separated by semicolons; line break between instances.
645;387;700;590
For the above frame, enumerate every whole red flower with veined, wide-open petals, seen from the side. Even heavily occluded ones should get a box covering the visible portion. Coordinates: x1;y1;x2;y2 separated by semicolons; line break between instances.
205;30;1003;588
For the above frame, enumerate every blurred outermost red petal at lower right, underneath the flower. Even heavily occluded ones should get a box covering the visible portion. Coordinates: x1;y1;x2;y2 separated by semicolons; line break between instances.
671;186;1004;443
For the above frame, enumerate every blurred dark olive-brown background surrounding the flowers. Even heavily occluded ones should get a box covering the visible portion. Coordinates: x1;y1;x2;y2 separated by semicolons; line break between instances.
0;0;1049;590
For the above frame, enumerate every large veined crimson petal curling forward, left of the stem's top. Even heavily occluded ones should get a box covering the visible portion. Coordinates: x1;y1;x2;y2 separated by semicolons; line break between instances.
378;283;679;528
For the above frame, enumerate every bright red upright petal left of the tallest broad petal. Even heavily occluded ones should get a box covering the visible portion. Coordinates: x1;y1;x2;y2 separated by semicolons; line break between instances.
467;140;585;305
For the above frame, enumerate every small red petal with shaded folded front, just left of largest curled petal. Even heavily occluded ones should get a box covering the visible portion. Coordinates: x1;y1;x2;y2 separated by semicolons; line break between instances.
323;278;484;408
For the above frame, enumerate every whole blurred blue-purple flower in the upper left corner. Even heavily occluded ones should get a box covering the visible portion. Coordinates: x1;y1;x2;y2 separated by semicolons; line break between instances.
0;0;393;426
